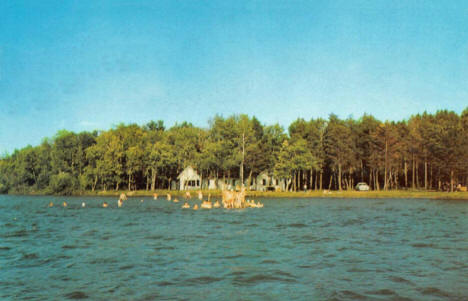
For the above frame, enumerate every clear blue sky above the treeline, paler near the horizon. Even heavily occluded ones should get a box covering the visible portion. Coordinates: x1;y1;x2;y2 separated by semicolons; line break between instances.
0;0;468;153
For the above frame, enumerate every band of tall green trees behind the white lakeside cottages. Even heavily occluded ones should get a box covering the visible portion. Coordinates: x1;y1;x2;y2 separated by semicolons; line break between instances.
0;107;468;195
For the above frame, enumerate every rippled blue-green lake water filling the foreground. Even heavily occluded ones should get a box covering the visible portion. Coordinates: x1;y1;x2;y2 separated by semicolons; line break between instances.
0;196;468;300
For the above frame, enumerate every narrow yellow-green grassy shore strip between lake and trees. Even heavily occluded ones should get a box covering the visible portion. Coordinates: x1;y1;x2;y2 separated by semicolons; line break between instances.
4;190;468;200
